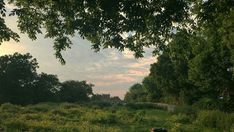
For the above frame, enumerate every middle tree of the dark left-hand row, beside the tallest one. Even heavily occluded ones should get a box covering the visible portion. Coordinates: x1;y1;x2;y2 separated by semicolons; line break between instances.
33;73;61;103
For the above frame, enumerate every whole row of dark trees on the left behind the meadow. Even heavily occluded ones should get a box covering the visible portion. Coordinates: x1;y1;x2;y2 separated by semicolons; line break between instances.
0;53;94;104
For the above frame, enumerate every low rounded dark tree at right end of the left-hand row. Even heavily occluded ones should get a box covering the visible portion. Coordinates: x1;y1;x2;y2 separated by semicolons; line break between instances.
58;80;94;102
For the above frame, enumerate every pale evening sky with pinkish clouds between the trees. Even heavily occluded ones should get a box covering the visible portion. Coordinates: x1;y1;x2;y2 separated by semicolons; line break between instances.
0;5;156;99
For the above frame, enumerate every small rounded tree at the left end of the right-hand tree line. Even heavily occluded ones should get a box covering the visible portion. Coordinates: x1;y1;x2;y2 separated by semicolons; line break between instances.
124;83;147;102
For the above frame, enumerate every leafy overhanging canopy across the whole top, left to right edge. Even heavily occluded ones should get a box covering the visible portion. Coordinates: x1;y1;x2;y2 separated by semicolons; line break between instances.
0;0;234;69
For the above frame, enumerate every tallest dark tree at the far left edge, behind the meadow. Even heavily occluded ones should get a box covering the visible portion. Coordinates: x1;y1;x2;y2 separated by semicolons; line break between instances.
0;53;38;104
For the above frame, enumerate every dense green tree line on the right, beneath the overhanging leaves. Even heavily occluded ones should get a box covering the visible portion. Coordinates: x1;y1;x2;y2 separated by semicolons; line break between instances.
125;28;234;111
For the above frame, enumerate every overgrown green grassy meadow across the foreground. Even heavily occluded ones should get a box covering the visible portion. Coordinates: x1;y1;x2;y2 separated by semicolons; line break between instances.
0;103;234;132
